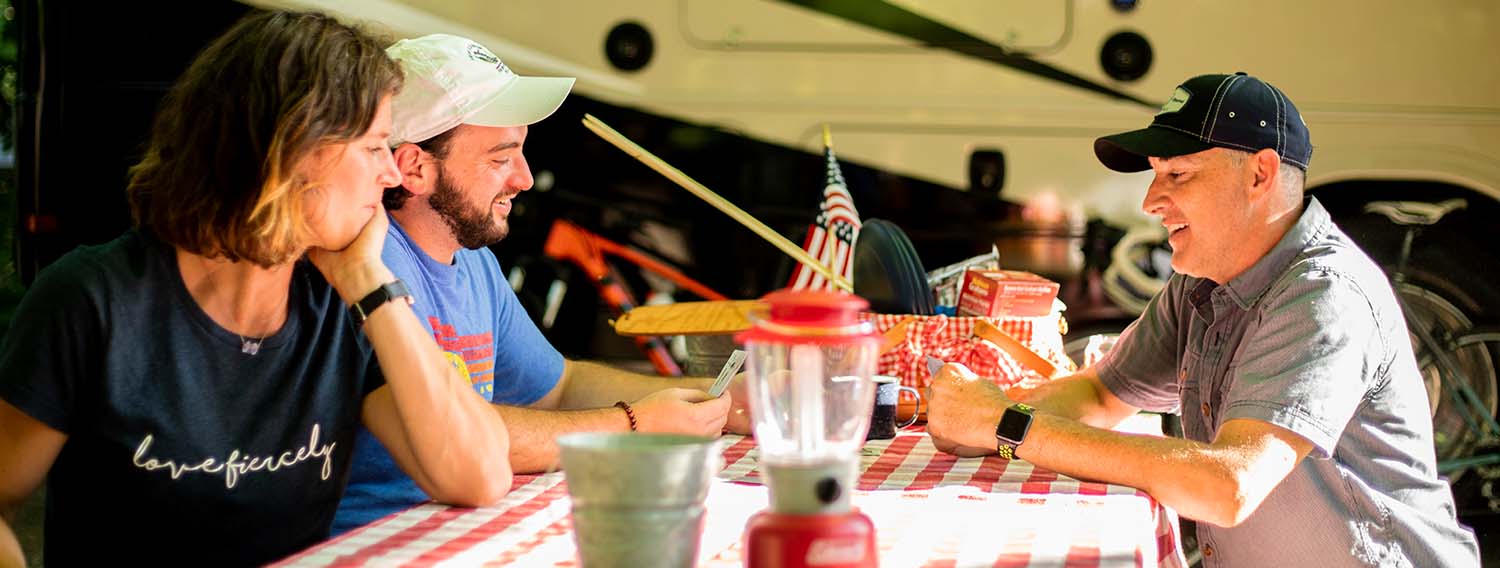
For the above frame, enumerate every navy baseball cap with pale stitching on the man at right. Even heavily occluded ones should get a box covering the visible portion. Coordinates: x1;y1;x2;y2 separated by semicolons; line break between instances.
1094;72;1313;172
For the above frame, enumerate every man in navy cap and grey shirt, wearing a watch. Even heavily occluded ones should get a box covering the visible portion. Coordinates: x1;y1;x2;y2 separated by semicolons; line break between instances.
927;73;1479;567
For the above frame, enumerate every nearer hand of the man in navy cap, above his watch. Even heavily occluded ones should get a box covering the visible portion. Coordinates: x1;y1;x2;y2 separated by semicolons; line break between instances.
927;363;1011;457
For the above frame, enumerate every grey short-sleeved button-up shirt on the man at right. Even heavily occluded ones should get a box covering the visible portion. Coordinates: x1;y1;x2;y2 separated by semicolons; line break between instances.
1097;199;1479;568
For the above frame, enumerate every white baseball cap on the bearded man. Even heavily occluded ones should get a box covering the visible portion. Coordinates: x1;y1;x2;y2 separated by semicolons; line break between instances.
386;33;573;147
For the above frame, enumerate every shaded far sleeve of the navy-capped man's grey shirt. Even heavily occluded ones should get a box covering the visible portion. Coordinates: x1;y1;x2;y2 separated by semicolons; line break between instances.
1094;274;1188;412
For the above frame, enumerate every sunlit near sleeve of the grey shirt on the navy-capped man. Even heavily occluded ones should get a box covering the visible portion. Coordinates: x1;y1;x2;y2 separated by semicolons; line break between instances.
1224;265;1388;459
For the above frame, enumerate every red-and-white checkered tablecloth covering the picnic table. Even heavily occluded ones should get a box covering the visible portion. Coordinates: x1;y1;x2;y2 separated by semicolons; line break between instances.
281;432;1187;568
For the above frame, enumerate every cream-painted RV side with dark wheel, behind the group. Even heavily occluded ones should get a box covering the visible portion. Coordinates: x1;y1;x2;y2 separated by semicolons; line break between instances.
264;0;1500;509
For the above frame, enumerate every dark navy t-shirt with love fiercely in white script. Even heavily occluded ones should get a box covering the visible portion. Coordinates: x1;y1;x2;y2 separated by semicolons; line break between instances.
0;231;384;565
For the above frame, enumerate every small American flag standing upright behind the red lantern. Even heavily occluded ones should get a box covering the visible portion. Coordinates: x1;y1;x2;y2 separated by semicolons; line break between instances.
789;130;860;289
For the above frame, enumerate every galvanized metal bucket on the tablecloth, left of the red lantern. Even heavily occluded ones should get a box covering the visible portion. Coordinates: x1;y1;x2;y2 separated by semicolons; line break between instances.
558;433;722;568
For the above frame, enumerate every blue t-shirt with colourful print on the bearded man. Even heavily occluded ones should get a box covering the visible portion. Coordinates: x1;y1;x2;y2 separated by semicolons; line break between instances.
333;219;563;535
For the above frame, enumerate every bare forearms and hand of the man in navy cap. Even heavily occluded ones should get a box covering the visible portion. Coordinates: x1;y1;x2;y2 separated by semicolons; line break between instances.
948;369;1313;526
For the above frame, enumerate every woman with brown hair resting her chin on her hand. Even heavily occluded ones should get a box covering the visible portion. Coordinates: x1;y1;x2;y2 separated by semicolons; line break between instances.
0;7;512;565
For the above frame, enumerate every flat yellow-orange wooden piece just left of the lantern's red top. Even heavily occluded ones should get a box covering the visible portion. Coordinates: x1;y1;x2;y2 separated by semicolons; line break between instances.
615;300;767;336
